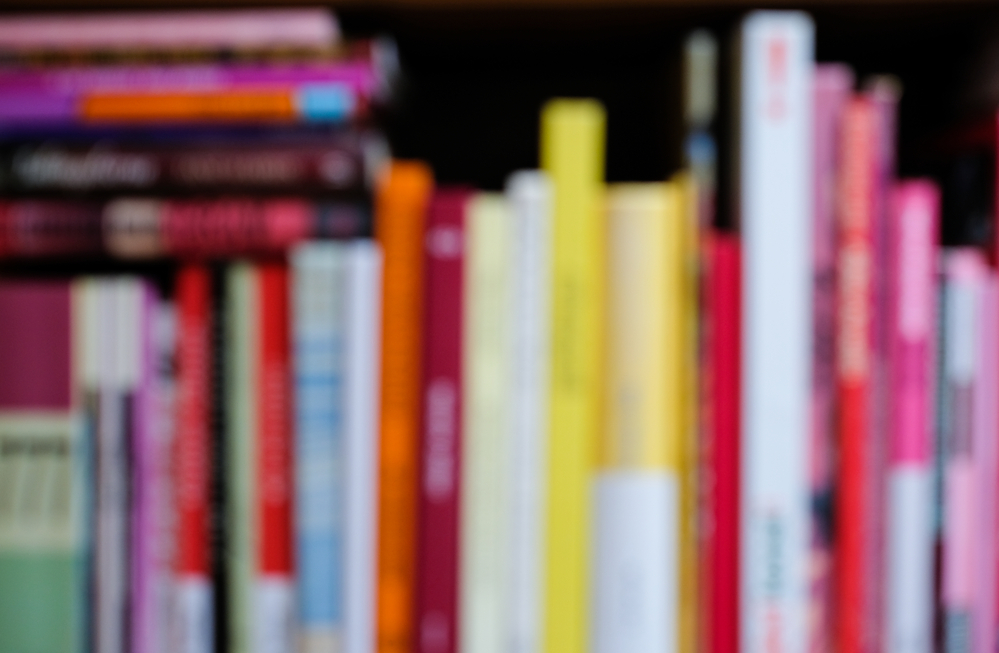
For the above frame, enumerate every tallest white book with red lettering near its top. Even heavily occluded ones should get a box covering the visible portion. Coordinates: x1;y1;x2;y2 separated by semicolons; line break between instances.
738;12;814;653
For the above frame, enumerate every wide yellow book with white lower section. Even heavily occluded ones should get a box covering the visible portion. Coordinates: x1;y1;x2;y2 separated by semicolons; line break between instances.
592;183;690;653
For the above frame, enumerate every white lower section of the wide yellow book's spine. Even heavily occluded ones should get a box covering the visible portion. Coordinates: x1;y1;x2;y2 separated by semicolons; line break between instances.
593;469;679;653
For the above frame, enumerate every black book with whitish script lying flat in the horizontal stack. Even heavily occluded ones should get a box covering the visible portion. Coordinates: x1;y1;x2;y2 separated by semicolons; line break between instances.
0;131;379;193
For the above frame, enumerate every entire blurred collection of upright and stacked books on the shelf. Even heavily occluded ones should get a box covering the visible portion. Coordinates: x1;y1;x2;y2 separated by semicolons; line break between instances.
0;10;999;653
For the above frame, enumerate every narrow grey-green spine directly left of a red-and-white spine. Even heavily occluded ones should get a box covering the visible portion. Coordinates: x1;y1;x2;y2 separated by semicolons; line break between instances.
223;261;260;653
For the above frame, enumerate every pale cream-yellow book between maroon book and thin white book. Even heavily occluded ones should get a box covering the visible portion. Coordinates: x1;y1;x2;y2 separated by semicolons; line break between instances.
459;193;513;653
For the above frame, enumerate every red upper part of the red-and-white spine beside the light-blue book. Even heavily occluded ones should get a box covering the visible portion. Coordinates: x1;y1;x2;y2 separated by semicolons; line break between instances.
256;263;293;579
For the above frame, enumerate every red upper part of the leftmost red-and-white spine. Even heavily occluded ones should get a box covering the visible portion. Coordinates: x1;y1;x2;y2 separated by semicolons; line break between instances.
174;265;212;581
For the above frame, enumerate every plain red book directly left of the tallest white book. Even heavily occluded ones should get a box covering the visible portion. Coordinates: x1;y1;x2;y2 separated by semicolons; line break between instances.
702;231;742;653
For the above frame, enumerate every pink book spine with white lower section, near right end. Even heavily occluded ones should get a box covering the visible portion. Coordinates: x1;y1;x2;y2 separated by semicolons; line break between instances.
883;181;940;653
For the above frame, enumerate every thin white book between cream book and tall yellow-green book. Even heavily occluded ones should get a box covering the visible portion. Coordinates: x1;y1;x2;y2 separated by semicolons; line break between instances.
506;171;552;653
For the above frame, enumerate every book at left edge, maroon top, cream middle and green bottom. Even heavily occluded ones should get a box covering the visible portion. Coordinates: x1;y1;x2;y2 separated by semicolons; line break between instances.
0;281;86;653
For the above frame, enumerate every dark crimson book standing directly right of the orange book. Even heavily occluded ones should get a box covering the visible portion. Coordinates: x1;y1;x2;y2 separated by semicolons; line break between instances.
417;190;469;653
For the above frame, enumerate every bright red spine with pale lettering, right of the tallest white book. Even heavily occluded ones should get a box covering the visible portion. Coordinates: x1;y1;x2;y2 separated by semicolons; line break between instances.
834;98;875;653
